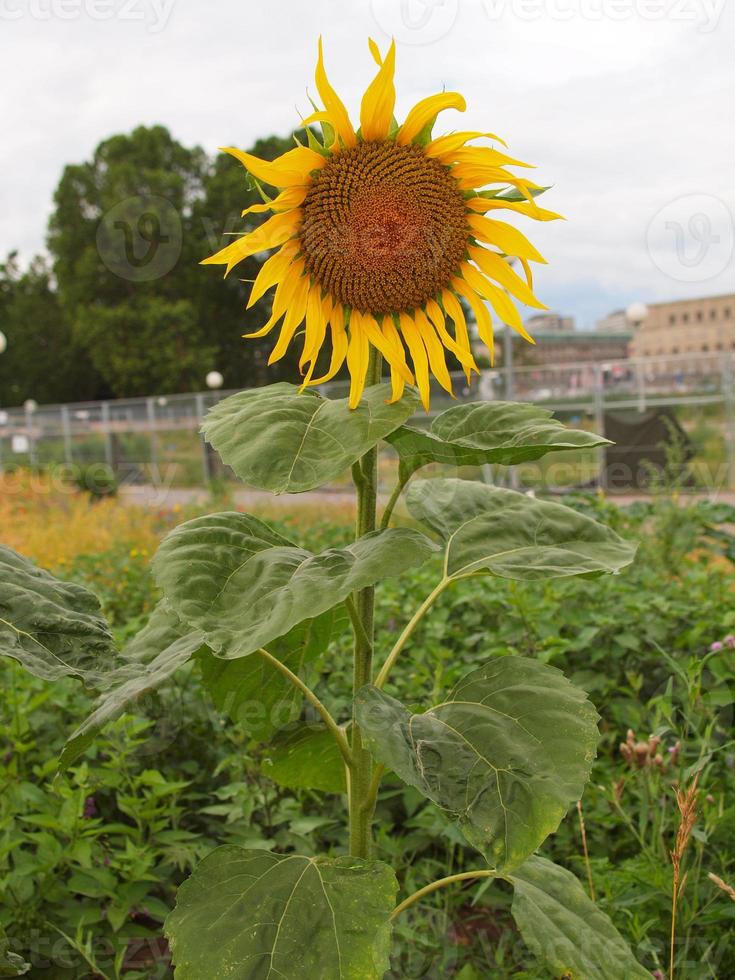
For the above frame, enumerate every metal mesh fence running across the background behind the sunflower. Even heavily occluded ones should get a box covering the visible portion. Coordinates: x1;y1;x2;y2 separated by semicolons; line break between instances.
0;352;735;490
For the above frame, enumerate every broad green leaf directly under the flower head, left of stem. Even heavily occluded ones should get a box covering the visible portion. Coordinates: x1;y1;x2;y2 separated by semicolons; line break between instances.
202;383;419;493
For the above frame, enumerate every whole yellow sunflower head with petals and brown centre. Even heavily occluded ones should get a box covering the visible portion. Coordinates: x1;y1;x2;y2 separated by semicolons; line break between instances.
204;40;559;409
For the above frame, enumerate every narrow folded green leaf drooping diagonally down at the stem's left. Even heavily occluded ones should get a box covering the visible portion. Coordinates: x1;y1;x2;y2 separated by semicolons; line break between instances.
59;602;204;770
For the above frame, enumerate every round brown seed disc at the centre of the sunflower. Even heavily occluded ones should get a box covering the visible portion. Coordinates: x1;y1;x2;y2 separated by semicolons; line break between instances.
300;142;469;314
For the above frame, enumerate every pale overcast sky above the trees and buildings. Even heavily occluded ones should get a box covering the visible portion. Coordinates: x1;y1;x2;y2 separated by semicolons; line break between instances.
0;0;735;326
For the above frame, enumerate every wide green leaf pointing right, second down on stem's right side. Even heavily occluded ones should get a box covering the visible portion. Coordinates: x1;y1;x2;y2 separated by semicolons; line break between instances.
407;479;635;579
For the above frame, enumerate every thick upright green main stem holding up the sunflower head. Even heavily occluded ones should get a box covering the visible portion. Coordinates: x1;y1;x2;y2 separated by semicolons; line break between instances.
348;347;382;858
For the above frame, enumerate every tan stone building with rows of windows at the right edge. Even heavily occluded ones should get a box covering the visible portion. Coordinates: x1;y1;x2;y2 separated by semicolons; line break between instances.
630;293;735;357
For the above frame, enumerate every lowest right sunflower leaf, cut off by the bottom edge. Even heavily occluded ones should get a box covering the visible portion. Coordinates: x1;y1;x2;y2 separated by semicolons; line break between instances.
510;857;651;980
